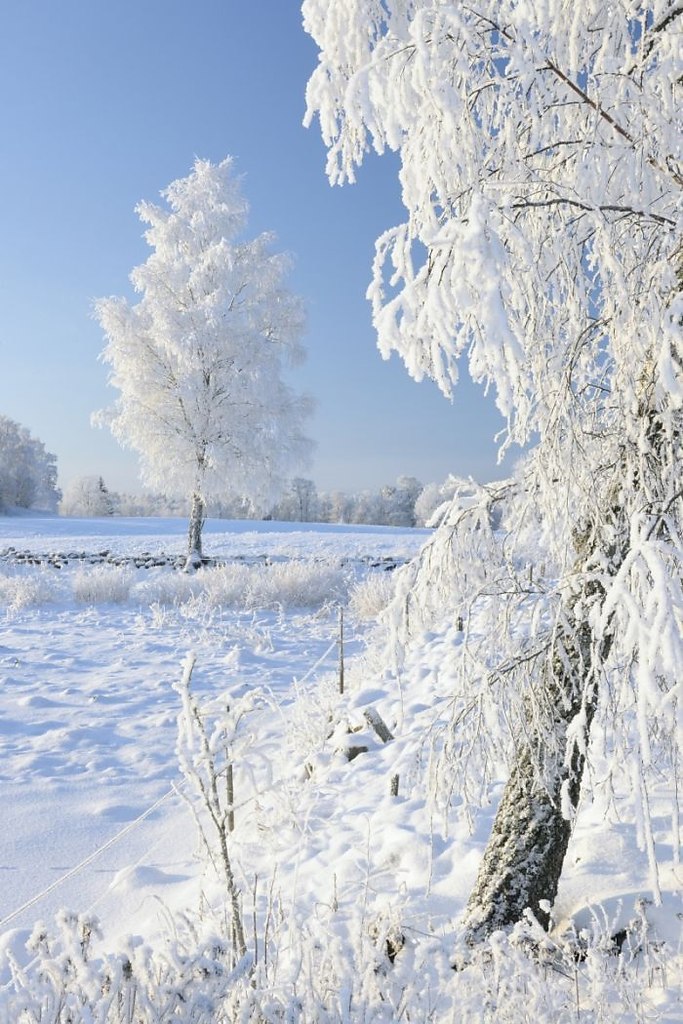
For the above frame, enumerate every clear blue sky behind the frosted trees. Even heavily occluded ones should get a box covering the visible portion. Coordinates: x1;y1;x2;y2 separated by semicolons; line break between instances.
0;0;509;492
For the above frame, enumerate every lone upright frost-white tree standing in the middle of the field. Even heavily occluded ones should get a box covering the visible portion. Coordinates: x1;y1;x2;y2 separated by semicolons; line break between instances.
95;158;310;564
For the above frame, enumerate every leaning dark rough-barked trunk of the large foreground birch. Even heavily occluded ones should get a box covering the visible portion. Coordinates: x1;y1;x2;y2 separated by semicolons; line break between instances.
465;479;638;943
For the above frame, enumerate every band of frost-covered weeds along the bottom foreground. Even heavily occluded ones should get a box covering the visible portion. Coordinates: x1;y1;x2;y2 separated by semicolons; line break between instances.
0;901;681;1024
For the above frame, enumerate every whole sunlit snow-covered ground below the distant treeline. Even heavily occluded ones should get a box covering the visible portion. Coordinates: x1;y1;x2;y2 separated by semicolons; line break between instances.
0;517;683;1024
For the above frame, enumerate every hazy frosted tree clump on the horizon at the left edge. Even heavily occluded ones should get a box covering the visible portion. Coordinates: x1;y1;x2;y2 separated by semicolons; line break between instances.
0;416;59;511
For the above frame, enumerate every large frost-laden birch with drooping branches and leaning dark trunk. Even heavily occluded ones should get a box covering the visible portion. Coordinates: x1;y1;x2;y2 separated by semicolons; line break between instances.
302;0;683;939
